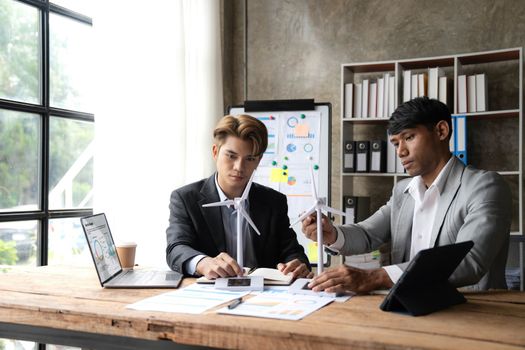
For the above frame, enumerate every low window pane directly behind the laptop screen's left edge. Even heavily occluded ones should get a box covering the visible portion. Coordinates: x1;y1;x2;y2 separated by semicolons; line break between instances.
48;218;89;265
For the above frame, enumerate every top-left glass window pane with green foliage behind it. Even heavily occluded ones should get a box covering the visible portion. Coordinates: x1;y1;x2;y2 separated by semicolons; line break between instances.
0;0;41;103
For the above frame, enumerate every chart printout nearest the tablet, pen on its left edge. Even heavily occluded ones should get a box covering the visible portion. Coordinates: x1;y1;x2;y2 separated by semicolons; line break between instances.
217;290;334;321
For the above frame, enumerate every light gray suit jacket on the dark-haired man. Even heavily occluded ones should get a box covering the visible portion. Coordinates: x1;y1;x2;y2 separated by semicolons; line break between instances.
340;157;512;290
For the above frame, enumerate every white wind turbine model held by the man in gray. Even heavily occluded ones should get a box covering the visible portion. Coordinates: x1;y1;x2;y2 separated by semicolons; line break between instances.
290;163;346;296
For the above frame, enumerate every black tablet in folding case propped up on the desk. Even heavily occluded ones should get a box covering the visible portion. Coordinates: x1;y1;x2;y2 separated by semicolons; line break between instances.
380;241;474;316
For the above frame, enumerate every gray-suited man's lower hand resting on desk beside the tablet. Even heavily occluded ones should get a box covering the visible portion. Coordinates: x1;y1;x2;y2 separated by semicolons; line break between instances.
308;265;393;293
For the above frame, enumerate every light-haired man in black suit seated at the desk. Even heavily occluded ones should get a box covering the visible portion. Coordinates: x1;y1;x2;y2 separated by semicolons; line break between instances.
166;115;311;279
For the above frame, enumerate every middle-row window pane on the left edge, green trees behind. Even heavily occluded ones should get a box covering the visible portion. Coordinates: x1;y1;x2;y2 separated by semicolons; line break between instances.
0;109;41;211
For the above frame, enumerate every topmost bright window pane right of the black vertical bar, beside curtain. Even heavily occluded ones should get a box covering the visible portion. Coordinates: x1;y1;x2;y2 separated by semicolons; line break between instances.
49;14;93;112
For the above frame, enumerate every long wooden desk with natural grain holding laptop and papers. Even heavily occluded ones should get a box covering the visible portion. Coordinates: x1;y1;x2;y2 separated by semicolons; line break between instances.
0;266;525;350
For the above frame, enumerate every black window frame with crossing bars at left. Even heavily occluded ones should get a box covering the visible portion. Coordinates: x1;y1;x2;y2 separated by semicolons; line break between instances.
0;0;95;266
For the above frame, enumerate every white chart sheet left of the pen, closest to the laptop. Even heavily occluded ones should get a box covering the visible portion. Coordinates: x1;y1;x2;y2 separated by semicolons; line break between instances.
126;284;249;314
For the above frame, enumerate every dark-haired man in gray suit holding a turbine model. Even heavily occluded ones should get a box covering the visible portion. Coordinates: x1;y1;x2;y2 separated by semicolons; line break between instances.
303;97;511;292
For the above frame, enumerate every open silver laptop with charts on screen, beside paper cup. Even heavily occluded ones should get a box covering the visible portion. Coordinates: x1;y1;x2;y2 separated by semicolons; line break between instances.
80;213;183;288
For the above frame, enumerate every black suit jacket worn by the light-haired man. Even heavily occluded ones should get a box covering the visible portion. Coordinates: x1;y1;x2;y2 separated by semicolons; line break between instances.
166;174;310;273
